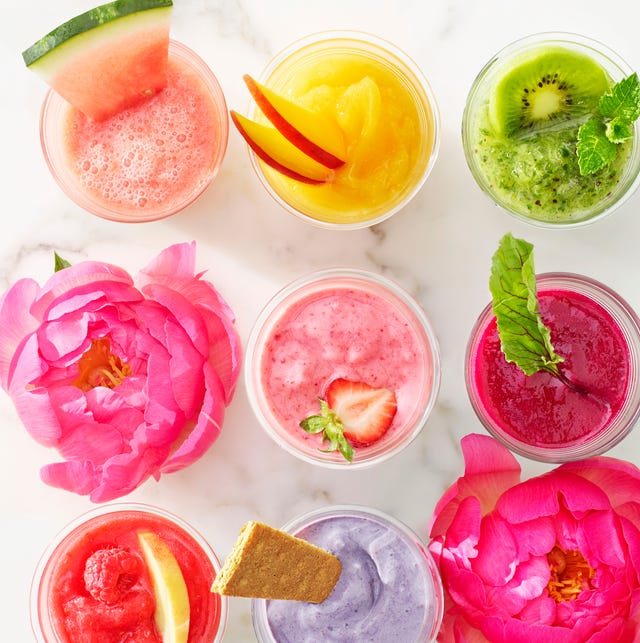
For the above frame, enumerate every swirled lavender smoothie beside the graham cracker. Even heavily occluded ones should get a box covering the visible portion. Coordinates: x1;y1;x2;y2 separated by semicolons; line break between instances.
267;516;432;643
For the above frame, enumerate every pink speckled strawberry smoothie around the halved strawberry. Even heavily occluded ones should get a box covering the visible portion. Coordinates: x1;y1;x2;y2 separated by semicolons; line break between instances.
259;278;435;461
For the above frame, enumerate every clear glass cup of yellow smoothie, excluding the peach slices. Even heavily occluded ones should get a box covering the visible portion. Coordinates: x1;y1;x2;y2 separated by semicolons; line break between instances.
242;31;440;230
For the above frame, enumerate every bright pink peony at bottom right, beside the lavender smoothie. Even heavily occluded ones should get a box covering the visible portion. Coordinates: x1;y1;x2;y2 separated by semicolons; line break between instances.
429;435;640;643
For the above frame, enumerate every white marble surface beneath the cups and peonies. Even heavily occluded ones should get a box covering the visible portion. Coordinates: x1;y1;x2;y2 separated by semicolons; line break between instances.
0;0;640;643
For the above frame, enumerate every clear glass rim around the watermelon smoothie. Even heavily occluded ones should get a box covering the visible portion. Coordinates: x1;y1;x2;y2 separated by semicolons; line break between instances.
40;40;229;223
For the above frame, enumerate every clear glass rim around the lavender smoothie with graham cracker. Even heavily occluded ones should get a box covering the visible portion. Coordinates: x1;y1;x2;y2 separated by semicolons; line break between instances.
251;504;444;643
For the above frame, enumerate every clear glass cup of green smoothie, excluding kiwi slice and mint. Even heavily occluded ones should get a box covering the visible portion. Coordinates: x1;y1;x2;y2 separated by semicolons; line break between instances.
462;33;640;228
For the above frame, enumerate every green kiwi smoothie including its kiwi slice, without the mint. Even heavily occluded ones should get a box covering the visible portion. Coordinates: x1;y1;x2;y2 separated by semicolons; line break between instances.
463;36;638;224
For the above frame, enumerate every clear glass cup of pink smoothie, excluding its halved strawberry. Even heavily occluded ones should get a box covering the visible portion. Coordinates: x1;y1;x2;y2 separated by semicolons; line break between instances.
244;268;440;468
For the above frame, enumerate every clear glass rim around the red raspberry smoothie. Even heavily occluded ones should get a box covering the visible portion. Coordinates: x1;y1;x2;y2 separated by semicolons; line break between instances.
29;502;229;643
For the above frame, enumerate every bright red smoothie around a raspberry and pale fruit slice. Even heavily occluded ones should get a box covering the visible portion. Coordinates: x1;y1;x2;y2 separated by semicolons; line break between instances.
38;510;221;643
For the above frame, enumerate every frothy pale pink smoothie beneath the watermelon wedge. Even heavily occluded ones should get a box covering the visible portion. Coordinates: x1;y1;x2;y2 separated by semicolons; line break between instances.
44;42;228;221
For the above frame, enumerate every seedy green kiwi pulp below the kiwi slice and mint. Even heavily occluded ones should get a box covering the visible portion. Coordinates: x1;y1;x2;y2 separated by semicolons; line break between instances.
463;45;633;224
